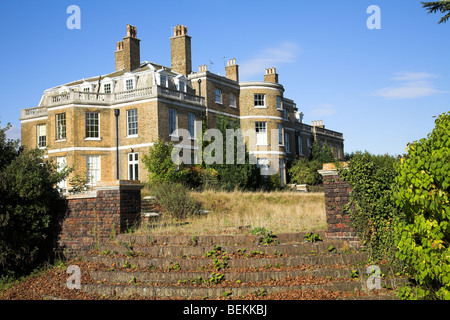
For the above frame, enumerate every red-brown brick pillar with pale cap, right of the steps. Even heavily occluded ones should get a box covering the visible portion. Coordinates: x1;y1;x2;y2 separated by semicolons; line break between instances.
319;163;357;244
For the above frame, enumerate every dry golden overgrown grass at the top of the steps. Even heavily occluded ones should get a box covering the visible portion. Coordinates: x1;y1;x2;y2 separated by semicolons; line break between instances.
136;191;326;235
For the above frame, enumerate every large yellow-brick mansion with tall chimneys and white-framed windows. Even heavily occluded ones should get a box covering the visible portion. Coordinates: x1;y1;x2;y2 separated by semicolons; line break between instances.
20;25;343;188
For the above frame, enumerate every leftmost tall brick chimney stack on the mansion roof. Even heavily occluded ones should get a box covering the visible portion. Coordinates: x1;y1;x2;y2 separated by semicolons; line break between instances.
115;24;141;72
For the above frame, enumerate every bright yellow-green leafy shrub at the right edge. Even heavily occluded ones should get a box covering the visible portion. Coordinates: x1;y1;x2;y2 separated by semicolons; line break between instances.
393;112;450;300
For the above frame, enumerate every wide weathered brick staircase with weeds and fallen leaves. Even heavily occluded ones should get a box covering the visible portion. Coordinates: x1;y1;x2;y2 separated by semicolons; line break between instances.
76;233;403;299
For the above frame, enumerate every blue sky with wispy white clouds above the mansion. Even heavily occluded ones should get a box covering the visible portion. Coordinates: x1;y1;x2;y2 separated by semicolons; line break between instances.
0;0;450;154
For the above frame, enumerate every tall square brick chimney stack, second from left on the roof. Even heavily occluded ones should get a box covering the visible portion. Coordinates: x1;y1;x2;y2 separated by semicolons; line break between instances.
170;24;192;76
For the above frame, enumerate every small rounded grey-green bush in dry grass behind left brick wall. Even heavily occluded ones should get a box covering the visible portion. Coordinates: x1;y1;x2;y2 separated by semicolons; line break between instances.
152;182;200;219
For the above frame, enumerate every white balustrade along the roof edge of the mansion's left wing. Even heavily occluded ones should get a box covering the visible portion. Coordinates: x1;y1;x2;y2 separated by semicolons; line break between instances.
21;86;205;119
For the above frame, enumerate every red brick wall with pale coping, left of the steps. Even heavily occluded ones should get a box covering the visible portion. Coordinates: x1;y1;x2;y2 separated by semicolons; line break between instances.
57;180;142;257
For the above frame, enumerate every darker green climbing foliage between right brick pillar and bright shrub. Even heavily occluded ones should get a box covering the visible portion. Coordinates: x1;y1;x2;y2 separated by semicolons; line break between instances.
339;152;400;260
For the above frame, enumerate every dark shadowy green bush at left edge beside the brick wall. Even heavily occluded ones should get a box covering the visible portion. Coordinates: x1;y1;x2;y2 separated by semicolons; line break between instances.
0;147;67;274
